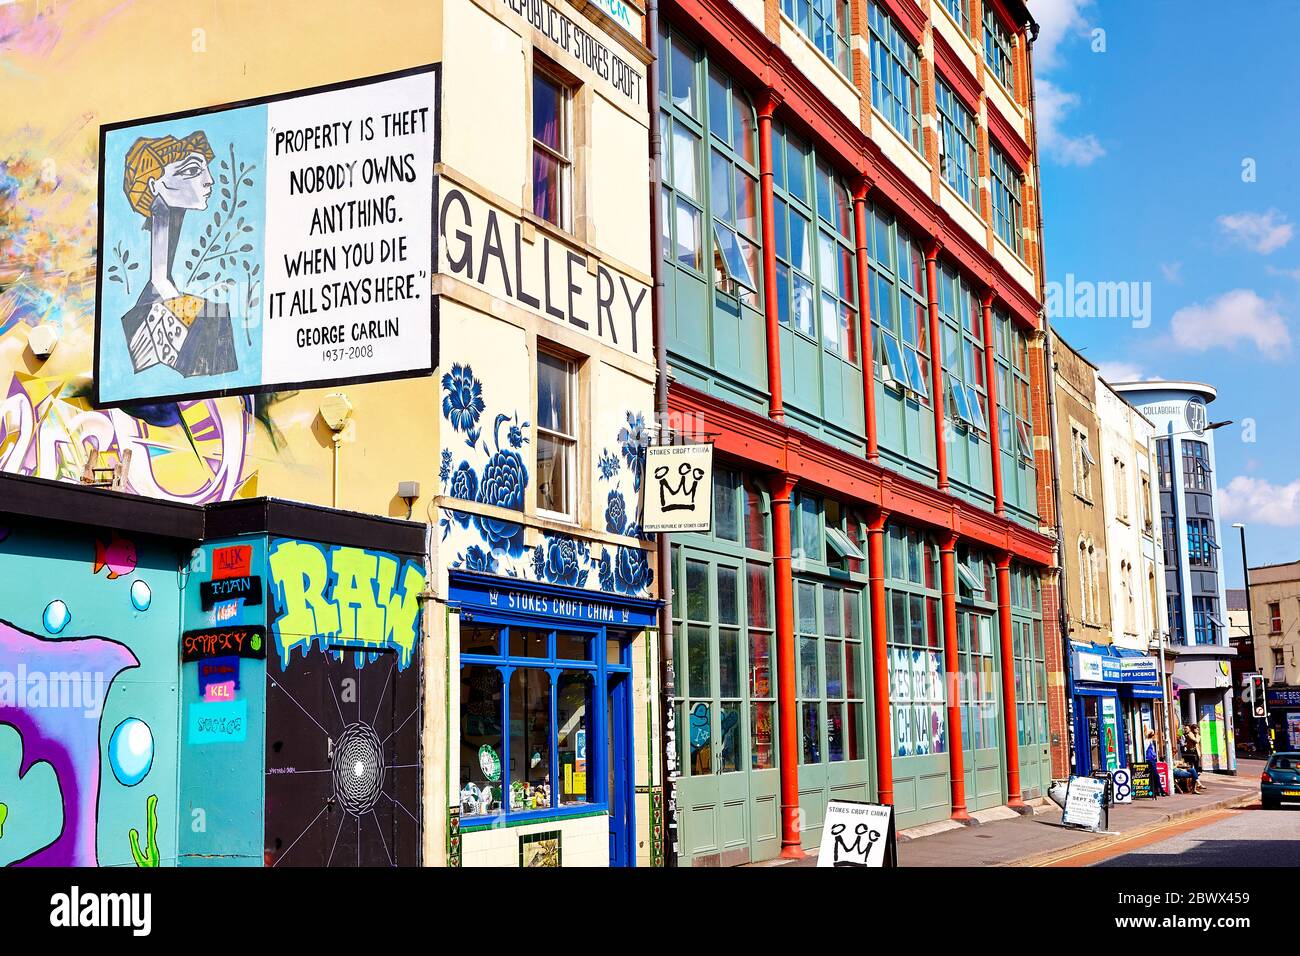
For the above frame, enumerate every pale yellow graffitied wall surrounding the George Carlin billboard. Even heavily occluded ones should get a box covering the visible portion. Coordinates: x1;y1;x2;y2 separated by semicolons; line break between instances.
0;0;439;516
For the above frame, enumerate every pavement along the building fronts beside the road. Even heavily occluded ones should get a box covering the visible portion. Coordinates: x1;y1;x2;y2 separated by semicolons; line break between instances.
755;760;1264;866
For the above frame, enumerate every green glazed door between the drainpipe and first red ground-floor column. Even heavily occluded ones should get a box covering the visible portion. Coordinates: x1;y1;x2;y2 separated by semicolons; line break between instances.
673;550;780;866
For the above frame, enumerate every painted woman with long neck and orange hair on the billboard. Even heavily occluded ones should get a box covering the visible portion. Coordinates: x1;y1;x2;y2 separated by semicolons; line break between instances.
122;130;238;377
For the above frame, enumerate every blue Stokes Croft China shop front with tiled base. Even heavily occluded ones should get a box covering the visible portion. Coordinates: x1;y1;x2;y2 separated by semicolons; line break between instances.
449;571;657;866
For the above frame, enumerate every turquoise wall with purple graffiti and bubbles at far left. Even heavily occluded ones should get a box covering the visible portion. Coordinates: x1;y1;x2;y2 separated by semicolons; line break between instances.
0;523;185;866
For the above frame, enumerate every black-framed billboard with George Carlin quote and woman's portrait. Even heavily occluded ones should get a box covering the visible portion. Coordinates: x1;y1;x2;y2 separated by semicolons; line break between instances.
95;65;439;405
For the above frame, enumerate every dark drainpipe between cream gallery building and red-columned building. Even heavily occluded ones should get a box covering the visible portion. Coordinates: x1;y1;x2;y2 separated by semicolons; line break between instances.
645;0;677;866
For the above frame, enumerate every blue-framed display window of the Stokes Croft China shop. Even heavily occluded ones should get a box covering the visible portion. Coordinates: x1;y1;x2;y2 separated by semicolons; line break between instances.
460;622;616;817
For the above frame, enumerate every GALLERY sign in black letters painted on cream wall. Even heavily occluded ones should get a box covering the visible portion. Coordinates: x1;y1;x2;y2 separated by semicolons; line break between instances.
438;181;653;362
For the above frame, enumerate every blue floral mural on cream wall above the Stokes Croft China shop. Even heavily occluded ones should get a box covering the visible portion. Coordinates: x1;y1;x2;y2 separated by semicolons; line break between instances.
438;363;654;597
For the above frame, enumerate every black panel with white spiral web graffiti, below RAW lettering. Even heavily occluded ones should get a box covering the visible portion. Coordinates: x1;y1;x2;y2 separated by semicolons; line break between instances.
265;643;420;866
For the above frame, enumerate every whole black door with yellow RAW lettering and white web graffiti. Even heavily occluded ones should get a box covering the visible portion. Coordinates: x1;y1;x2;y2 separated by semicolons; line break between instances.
265;540;425;866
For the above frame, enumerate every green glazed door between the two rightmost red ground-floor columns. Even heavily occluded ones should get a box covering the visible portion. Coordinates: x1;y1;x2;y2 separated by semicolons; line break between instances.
957;607;1006;810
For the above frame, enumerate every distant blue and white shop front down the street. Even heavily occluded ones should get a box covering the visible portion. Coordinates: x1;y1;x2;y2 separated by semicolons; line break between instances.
1070;641;1165;774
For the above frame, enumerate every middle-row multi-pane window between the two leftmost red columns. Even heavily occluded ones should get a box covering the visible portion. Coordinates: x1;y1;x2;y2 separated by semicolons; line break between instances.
772;127;858;364
